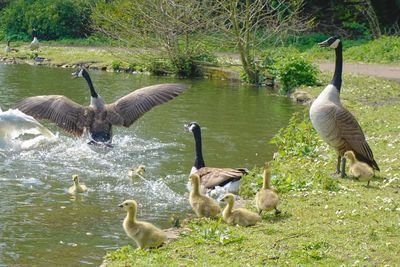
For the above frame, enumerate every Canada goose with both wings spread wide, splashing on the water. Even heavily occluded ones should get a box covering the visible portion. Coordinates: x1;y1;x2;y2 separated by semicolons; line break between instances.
14;69;187;145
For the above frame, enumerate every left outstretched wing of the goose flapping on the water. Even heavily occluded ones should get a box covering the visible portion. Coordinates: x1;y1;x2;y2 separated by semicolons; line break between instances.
14;95;94;136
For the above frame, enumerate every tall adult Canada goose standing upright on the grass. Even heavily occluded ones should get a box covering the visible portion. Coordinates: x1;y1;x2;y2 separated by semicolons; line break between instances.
310;37;379;177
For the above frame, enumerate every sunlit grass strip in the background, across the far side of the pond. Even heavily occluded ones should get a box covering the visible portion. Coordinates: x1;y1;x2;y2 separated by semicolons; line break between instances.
0;36;400;75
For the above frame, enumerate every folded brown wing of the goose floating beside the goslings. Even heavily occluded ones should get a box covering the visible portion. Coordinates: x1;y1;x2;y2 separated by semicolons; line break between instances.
196;167;247;188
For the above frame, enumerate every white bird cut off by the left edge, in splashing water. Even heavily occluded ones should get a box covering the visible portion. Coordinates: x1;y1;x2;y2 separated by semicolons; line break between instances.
0;108;55;139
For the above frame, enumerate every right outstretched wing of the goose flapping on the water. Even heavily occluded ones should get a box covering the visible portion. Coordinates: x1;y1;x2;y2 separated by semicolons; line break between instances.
106;84;188;127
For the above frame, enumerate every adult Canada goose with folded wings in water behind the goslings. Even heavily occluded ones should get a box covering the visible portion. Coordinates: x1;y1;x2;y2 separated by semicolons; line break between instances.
185;122;248;195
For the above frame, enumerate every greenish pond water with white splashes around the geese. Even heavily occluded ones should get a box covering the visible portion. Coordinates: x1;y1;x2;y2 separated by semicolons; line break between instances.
0;65;302;266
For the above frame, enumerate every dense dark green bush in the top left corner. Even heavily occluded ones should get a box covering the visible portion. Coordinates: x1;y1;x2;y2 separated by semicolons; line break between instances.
0;0;91;41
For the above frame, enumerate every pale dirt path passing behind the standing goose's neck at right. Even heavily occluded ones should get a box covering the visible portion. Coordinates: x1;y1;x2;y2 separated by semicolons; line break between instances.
317;62;400;82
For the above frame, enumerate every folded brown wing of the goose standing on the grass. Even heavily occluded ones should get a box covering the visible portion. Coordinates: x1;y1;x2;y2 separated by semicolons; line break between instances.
336;107;379;170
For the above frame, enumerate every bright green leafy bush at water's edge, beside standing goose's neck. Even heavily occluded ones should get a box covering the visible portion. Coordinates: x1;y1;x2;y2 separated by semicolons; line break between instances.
263;53;318;94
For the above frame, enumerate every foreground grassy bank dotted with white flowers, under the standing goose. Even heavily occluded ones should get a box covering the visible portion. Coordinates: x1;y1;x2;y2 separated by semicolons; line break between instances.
105;74;400;266
